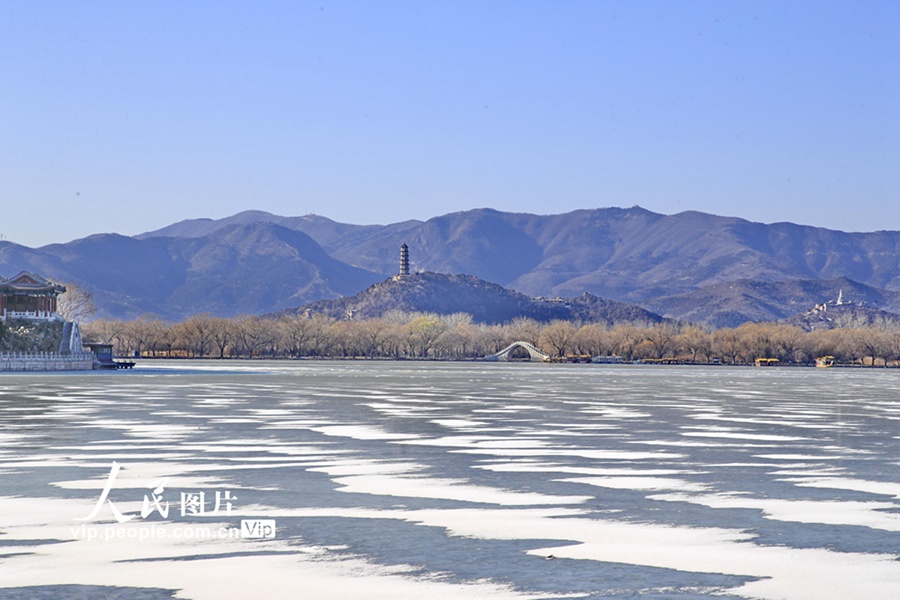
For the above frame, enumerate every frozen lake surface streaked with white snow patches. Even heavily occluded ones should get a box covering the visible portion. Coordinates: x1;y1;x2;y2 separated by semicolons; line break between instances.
0;361;900;600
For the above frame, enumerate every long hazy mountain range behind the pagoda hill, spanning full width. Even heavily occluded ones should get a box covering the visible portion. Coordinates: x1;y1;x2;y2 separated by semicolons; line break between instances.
0;207;900;325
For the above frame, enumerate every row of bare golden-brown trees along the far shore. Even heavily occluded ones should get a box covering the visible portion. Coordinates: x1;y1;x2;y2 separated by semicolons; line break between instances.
83;311;900;367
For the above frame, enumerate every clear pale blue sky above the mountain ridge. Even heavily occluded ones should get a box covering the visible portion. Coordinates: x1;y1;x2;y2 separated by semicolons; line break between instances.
0;0;900;246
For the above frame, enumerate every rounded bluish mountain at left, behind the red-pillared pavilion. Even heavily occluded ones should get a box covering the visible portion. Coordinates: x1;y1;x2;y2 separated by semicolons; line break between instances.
0;223;380;319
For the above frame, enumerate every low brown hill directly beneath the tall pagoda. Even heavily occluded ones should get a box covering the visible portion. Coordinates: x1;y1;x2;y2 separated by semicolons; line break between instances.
282;273;662;324
